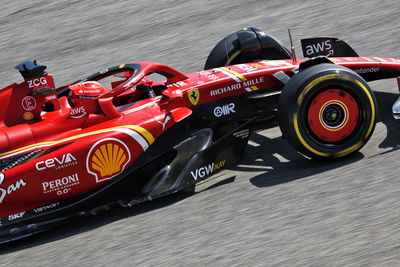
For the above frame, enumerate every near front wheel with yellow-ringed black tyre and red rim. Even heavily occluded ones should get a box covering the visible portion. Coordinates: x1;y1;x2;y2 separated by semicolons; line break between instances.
278;64;376;159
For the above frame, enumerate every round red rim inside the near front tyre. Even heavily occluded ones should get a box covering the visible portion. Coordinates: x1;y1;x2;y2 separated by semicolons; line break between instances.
307;89;360;142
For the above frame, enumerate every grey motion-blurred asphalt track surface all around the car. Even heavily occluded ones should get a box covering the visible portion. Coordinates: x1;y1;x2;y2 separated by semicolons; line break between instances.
0;0;400;266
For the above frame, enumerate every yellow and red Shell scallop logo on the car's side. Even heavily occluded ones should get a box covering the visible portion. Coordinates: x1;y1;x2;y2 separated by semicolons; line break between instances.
86;138;131;183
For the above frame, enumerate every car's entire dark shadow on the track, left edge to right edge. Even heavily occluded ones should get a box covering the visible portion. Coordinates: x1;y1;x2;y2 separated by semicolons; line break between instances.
0;92;400;255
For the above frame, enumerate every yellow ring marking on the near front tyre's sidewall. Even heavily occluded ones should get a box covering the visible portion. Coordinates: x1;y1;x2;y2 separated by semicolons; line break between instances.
293;74;375;157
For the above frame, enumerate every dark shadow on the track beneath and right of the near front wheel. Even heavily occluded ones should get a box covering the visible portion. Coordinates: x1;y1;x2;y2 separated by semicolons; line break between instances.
244;92;400;187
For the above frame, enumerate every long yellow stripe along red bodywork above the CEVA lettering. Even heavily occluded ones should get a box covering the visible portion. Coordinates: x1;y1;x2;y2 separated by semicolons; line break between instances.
0;125;154;157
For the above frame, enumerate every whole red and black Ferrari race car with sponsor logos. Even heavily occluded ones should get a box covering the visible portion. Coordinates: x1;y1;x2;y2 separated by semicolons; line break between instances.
0;28;400;243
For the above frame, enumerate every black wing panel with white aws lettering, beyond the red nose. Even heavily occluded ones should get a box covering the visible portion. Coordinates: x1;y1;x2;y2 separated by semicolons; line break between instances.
301;37;358;58
